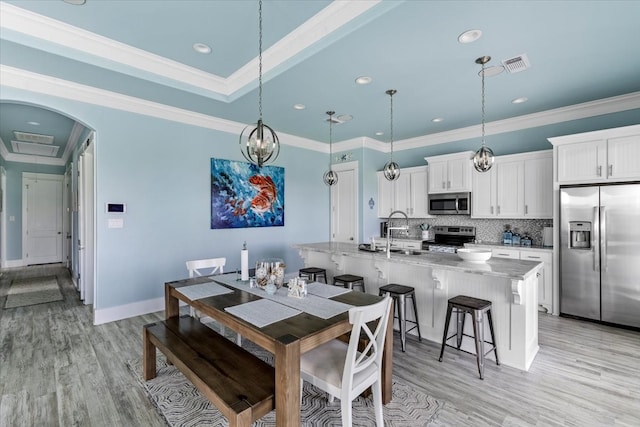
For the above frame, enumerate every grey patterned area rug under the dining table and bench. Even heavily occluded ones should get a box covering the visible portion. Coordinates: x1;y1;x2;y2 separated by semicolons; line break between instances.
128;340;443;427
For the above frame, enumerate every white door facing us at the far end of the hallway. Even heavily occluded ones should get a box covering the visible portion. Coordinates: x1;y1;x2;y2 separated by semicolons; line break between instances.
22;172;64;265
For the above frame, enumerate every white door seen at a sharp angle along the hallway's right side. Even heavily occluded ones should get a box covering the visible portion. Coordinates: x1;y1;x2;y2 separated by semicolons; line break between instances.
78;142;95;304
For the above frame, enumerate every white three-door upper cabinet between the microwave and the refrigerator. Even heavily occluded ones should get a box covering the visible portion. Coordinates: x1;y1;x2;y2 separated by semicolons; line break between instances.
471;151;553;218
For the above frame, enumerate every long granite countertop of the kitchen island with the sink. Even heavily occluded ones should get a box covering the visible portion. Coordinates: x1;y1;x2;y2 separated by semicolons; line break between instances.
292;242;543;280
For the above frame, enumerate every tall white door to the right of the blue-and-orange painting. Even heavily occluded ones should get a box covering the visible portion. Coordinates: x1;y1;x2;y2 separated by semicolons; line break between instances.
331;162;358;243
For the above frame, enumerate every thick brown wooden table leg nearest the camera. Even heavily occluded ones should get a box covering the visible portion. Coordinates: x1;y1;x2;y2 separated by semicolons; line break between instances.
275;335;300;427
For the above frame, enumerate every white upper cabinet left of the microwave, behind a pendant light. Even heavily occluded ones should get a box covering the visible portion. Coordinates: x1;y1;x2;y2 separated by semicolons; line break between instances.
378;166;429;218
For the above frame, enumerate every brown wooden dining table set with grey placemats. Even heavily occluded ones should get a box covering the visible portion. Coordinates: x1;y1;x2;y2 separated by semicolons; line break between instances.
165;273;393;427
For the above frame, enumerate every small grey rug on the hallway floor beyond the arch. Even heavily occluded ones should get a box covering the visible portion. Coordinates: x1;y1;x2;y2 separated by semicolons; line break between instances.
4;276;63;308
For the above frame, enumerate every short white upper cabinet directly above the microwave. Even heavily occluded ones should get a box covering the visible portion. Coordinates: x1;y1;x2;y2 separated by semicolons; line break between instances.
425;151;473;194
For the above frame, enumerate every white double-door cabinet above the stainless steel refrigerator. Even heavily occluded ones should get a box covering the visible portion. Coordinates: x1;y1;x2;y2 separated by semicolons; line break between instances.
549;125;640;184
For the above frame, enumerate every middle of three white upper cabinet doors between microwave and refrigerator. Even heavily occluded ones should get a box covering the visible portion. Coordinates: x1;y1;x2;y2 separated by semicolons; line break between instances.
496;161;524;218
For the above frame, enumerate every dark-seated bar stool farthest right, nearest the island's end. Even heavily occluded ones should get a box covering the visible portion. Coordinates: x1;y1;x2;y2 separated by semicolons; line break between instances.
439;295;500;380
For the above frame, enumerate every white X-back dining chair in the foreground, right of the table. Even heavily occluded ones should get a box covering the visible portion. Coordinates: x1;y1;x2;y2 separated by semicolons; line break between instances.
300;296;391;427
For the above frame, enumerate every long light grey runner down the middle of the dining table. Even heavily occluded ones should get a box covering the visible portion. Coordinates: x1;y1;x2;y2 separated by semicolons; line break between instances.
211;274;353;319
